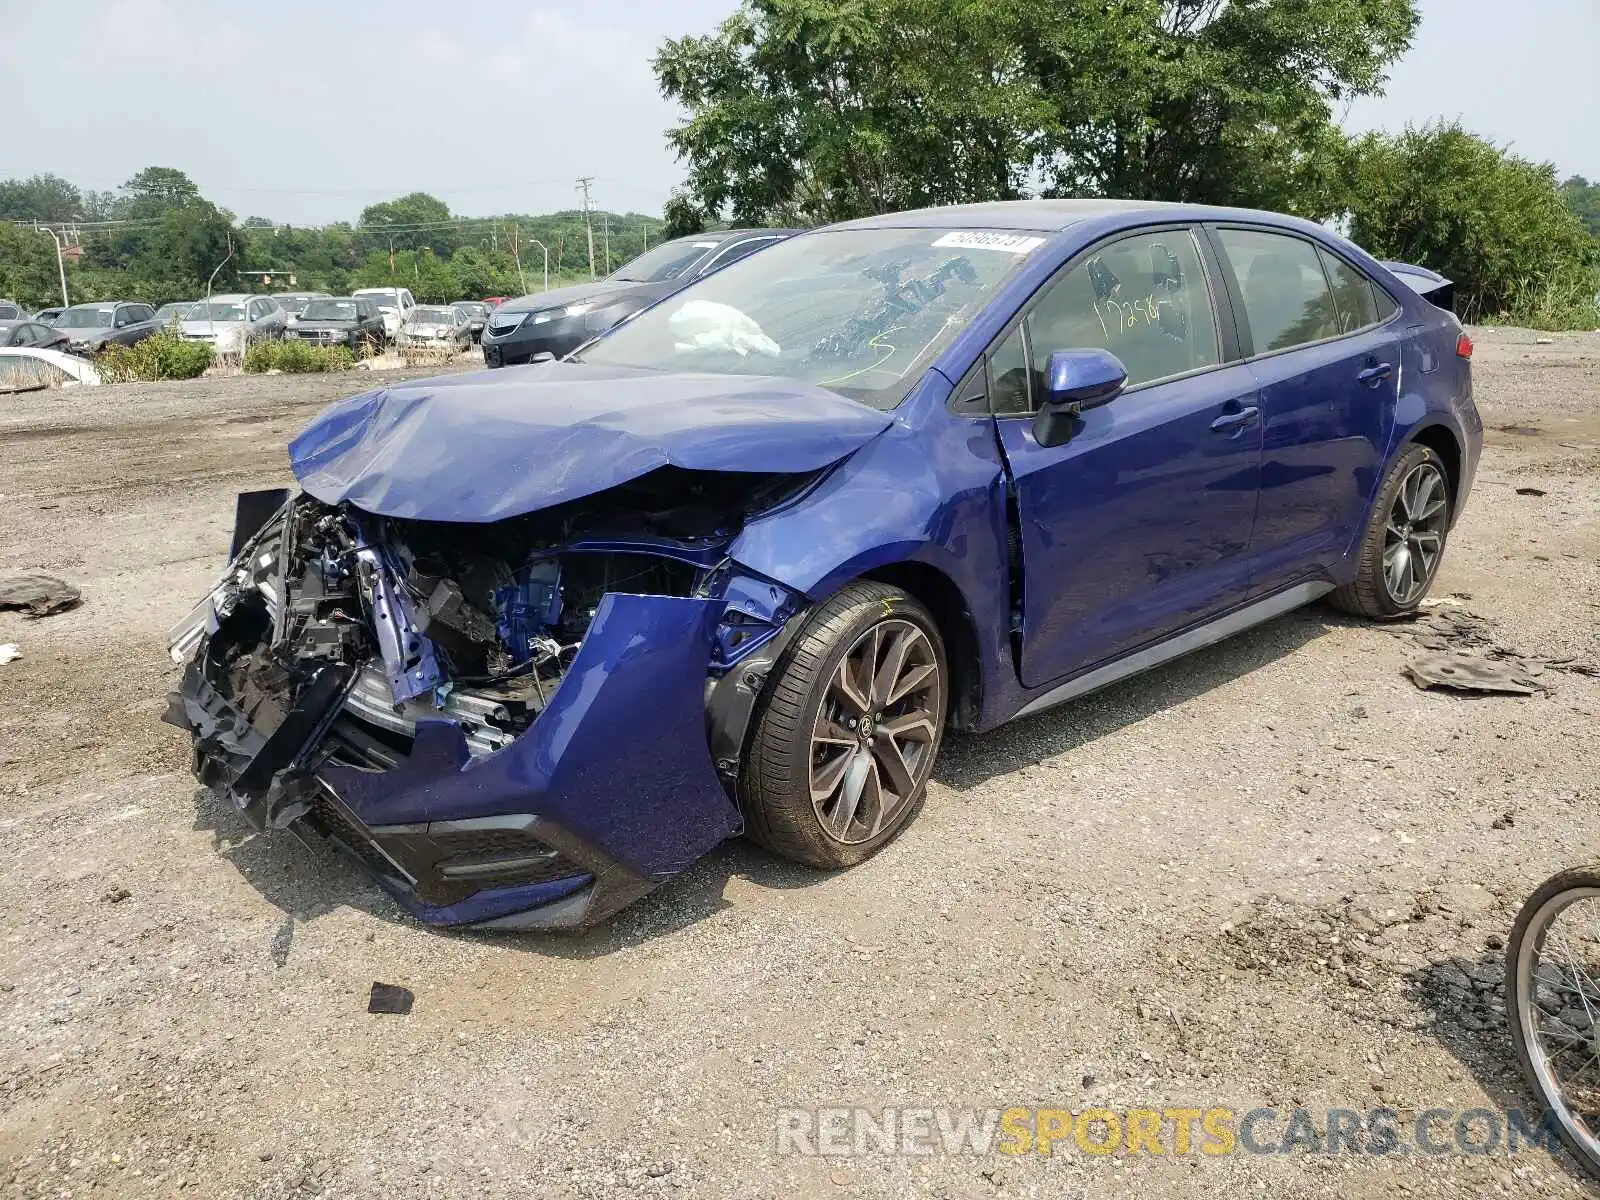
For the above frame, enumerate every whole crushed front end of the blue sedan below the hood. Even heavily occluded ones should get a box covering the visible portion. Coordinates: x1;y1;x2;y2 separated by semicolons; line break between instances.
166;467;805;928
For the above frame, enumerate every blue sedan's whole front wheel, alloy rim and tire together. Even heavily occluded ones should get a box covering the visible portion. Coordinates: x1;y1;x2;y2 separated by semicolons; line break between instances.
739;582;947;867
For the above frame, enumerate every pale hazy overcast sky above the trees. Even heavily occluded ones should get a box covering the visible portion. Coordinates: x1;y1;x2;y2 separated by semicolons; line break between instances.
0;0;1600;224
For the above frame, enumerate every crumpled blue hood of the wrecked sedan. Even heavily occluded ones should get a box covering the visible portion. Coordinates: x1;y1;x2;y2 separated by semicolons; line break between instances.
290;363;893;523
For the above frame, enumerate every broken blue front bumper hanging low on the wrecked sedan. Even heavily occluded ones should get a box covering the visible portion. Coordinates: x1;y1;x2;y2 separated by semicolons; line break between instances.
166;512;741;930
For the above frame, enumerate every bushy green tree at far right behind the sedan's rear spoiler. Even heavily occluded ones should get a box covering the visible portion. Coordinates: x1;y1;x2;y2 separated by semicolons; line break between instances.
1347;123;1594;320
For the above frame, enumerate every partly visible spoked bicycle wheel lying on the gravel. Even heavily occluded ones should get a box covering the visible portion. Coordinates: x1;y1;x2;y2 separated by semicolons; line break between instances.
1506;869;1600;1176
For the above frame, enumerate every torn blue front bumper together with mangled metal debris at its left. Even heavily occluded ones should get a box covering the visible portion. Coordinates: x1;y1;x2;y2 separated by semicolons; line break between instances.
165;498;755;928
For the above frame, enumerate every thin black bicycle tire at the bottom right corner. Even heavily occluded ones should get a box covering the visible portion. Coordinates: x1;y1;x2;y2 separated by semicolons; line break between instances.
1506;867;1600;1179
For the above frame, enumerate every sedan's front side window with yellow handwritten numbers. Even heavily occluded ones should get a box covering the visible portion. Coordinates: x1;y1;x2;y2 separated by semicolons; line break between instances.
1017;229;1216;395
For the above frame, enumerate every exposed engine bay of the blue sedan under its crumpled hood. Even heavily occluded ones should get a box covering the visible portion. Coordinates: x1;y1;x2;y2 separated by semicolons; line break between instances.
173;467;805;790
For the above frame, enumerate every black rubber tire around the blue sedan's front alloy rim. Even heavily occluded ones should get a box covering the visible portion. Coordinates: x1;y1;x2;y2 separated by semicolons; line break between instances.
739;582;949;869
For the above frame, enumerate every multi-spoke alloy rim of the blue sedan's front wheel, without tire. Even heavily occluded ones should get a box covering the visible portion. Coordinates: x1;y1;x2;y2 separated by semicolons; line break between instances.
811;618;944;845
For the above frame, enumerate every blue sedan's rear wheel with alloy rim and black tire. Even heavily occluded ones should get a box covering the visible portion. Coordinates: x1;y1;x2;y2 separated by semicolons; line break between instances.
1331;445;1450;619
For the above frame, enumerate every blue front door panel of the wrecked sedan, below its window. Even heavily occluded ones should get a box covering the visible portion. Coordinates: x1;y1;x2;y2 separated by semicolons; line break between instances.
1000;365;1261;686
